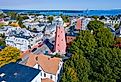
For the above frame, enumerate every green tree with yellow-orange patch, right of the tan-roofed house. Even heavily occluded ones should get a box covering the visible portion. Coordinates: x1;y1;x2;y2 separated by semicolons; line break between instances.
61;51;90;82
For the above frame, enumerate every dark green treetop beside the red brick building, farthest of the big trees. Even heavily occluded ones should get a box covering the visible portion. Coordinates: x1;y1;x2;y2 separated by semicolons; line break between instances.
87;20;104;30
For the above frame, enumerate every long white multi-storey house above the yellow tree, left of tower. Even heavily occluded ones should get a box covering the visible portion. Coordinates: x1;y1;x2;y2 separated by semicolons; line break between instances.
5;36;42;51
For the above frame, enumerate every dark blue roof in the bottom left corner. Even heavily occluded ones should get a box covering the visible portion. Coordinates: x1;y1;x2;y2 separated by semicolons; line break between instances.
0;63;40;82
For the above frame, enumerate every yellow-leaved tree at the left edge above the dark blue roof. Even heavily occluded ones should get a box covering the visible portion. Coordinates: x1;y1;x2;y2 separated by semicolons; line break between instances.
0;46;20;66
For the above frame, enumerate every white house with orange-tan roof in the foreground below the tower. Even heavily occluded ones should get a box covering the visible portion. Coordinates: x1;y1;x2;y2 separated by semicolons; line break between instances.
26;54;63;82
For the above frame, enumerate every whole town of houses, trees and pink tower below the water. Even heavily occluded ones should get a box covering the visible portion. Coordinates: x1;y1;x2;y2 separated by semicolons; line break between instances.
0;11;121;82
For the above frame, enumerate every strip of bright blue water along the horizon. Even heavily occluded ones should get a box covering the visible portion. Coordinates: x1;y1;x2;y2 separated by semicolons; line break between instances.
2;9;121;16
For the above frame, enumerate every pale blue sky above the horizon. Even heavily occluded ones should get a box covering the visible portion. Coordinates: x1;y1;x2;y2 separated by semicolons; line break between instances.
0;0;121;10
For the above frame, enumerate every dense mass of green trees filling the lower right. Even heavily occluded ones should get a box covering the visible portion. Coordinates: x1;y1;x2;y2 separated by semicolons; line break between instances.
61;24;121;82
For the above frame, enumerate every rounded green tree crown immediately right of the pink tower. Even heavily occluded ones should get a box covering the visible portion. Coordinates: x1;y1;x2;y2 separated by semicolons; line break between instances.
69;31;97;55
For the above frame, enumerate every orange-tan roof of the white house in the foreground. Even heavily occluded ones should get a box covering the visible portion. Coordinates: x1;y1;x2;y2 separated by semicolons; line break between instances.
26;54;61;74
